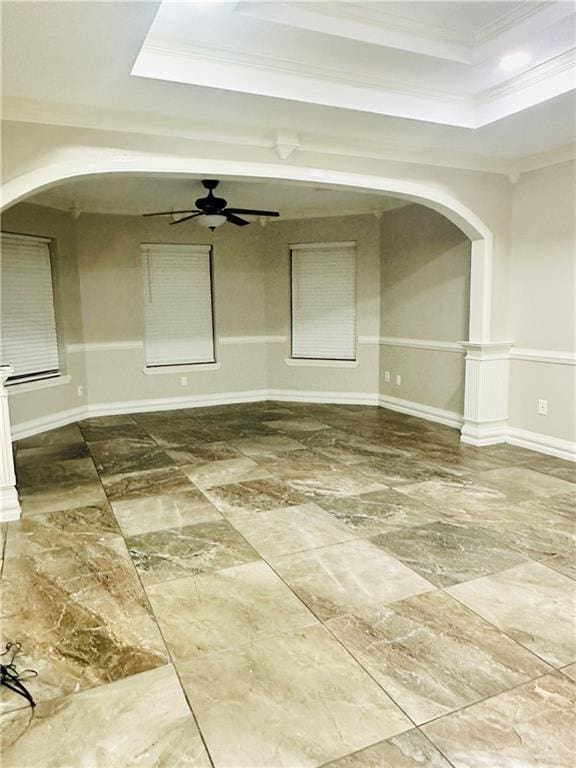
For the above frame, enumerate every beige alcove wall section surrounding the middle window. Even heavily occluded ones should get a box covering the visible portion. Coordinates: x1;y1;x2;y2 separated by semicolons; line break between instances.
78;210;266;404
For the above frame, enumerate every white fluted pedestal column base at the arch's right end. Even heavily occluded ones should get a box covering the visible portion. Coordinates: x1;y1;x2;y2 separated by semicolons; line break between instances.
461;341;512;446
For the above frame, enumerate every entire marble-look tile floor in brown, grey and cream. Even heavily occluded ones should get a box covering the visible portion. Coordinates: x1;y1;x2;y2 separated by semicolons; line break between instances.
0;403;576;768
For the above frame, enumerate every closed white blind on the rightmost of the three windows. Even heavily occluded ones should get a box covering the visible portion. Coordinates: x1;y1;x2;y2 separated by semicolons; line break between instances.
291;243;356;360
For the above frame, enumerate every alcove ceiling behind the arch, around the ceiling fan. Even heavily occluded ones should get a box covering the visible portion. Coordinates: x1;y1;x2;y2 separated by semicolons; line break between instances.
27;174;406;219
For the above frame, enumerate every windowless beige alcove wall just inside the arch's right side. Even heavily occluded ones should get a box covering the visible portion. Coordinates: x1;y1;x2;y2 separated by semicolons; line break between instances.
380;205;470;414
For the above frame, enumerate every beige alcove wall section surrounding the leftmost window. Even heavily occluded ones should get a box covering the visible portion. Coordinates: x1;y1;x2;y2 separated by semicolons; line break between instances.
2;203;87;424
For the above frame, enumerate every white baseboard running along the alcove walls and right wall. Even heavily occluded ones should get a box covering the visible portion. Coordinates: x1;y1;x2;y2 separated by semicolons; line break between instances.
7;389;576;461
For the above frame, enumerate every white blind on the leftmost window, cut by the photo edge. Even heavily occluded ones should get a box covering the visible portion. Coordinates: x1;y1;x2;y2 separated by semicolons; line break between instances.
0;234;59;379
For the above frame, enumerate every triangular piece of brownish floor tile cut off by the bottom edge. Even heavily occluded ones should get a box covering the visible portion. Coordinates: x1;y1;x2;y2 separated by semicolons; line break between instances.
324;728;452;768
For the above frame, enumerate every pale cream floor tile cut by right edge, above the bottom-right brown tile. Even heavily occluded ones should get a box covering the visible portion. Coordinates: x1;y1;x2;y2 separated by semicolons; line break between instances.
448;561;576;667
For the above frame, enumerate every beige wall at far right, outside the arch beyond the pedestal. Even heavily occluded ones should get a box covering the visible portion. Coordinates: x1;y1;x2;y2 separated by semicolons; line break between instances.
509;162;576;441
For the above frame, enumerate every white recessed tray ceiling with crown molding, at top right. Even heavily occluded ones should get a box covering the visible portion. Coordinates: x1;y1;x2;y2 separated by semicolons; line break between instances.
132;0;576;128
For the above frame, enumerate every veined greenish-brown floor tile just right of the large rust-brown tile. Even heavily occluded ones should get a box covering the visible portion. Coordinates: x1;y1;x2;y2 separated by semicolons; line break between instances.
126;520;260;584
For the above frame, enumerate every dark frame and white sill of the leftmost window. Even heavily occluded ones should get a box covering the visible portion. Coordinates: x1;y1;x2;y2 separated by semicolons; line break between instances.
0;229;61;384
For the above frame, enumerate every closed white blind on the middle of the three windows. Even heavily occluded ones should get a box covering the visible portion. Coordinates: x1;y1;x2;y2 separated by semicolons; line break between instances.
142;243;215;366
